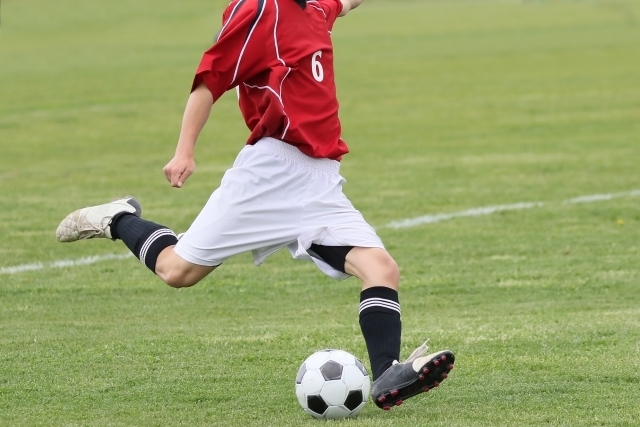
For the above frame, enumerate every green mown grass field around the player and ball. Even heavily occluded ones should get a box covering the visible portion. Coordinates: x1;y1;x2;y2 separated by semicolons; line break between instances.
0;0;640;427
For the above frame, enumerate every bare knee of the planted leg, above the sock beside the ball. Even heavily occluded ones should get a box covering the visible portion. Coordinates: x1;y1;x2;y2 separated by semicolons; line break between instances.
344;247;400;289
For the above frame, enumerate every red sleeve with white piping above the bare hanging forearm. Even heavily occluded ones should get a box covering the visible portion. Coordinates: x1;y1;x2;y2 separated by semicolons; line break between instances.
191;0;267;102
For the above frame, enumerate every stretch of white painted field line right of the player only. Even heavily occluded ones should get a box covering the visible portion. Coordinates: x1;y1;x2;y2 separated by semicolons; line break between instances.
385;190;640;229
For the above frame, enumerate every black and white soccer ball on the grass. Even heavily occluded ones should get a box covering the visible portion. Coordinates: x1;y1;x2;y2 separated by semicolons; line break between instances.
296;350;371;419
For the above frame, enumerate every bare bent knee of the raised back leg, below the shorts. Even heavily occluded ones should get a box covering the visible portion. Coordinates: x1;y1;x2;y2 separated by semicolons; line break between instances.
156;246;217;288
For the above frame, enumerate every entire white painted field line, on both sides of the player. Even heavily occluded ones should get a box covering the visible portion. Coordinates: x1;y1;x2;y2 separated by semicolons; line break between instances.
0;190;640;274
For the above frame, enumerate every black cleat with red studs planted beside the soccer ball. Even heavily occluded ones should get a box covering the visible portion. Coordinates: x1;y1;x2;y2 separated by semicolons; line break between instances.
371;342;455;411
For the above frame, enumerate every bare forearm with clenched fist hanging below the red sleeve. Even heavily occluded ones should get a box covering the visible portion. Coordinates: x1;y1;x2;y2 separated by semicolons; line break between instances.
164;83;213;188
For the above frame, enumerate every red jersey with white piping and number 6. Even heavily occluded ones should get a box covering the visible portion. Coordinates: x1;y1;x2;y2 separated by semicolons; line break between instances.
193;0;349;160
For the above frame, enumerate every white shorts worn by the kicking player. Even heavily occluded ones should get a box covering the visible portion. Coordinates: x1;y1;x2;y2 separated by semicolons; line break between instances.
175;138;384;279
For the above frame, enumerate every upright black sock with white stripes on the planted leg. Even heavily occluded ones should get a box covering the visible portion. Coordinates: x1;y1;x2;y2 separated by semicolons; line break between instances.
360;286;402;380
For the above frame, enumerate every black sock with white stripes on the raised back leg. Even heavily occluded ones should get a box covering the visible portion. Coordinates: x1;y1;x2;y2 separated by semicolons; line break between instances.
109;213;178;273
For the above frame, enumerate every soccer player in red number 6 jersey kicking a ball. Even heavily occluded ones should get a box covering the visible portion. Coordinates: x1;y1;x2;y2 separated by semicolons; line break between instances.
56;0;454;409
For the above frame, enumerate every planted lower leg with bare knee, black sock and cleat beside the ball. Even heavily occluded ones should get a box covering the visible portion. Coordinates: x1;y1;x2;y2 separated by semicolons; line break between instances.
344;247;455;410
